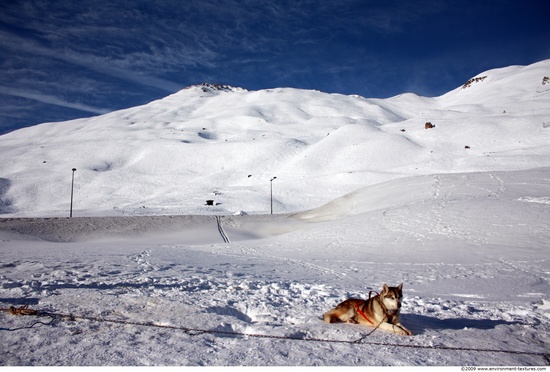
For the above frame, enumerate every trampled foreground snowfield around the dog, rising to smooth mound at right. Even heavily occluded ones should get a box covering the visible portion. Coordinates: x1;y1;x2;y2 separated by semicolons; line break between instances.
0;168;550;367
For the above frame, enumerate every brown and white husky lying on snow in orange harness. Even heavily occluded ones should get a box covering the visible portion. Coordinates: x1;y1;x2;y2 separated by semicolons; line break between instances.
323;283;412;336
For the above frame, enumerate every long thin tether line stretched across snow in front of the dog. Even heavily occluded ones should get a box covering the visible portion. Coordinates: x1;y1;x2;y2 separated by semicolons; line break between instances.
4;308;550;364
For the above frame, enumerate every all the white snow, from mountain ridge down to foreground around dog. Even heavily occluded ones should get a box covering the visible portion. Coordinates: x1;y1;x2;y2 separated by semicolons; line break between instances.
0;61;550;366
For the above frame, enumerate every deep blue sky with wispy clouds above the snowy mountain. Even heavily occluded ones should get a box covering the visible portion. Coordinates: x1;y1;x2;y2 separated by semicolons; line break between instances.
0;0;550;134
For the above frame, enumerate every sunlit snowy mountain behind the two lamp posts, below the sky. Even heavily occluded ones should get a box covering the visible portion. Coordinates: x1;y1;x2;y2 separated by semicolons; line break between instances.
0;61;550;216
